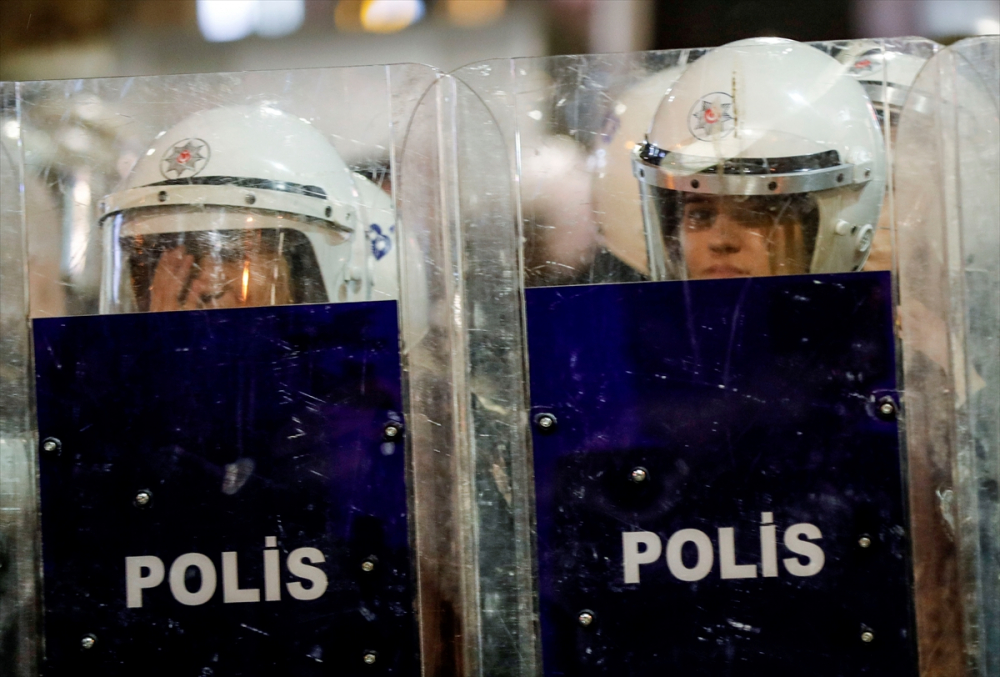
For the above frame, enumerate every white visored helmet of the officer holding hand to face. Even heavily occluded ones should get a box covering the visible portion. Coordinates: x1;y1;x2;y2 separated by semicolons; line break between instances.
101;105;397;312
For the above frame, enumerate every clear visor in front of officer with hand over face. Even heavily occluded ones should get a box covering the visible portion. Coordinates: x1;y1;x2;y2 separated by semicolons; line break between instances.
101;205;346;313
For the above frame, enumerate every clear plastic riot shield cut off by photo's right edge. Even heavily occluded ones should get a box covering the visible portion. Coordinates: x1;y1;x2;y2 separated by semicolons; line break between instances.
896;36;1000;675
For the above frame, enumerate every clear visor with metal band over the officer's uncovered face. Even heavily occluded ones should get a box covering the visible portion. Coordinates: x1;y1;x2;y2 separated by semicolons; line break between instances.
633;144;873;280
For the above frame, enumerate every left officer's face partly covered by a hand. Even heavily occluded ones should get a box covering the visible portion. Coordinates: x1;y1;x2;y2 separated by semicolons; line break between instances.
149;245;292;311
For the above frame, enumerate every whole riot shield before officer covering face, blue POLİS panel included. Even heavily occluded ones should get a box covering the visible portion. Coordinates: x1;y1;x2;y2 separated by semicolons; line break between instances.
0;65;450;675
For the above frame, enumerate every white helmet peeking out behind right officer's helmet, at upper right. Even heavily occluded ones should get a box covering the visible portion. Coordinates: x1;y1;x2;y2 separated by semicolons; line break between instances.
837;40;937;126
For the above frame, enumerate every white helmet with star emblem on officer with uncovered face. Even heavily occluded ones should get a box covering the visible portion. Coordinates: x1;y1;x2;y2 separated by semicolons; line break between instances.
634;38;886;279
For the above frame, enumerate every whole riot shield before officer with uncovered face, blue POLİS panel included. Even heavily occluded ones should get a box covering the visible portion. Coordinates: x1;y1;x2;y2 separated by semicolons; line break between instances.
435;38;996;675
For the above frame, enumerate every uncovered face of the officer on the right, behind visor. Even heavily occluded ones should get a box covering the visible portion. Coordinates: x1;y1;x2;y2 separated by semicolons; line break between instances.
681;193;808;280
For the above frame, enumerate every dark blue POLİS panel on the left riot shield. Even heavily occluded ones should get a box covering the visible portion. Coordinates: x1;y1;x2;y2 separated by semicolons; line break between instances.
34;301;418;675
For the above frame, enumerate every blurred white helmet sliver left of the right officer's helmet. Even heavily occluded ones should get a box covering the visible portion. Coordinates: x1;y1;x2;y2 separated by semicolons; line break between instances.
591;66;684;275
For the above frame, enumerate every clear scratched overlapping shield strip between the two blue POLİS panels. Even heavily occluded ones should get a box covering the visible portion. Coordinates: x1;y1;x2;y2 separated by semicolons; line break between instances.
400;70;537;677
